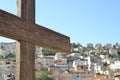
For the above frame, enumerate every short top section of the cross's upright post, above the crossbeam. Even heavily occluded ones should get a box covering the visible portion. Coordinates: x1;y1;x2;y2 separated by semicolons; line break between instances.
17;0;35;23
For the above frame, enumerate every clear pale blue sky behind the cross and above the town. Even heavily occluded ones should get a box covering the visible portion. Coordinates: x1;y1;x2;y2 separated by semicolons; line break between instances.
0;0;120;45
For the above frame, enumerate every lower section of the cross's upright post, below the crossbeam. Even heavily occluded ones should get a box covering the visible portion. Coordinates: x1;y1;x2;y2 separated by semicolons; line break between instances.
15;41;35;80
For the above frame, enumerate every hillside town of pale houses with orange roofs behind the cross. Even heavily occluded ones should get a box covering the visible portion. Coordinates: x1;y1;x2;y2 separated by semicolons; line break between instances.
0;42;120;80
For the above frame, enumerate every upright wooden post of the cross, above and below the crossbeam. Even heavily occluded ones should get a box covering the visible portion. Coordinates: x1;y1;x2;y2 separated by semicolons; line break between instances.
16;0;35;80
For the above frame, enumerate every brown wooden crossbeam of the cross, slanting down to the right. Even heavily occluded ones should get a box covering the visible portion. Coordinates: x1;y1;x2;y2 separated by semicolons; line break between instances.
0;10;70;53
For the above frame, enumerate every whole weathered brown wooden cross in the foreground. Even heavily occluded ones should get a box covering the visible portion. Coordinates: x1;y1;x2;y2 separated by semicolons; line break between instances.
0;0;70;80
